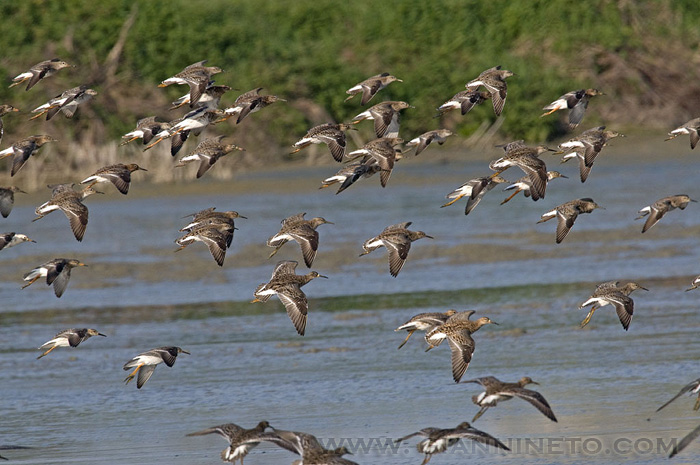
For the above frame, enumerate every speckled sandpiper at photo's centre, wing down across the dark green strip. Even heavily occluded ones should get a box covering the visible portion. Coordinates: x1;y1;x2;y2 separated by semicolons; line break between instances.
252;261;327;336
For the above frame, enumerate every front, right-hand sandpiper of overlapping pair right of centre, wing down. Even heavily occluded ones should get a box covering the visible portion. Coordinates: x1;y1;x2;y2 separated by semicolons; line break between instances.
425;310;498;383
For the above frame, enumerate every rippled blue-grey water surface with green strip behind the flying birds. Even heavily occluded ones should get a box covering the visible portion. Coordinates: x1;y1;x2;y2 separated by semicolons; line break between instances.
0;151;700;464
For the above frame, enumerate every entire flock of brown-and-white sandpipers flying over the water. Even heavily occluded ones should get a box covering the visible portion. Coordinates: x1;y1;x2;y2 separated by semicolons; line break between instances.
0;59;700;465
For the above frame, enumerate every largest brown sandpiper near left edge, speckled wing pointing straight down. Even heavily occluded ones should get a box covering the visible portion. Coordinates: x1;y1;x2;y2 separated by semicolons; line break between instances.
32;184;102;242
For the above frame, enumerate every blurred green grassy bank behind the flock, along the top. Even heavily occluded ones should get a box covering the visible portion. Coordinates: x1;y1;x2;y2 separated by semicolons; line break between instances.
0;0;700;177
